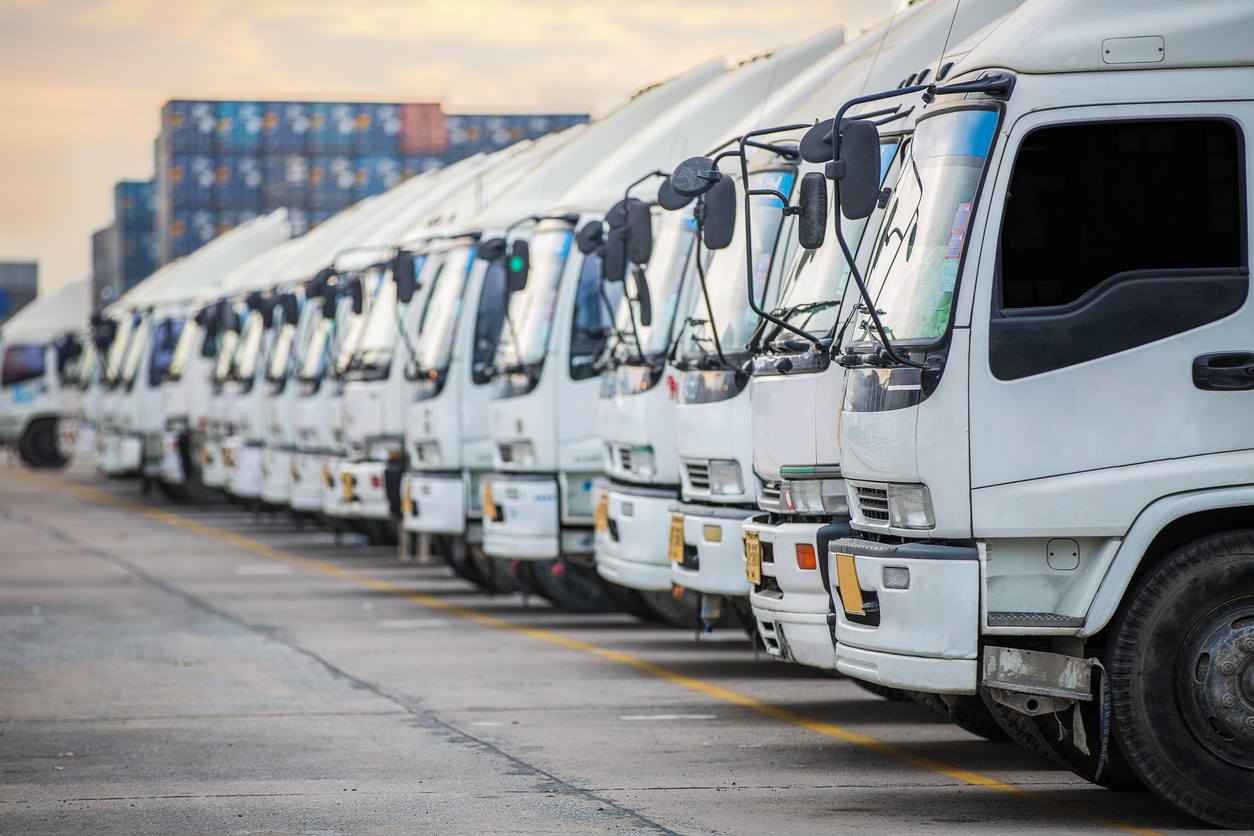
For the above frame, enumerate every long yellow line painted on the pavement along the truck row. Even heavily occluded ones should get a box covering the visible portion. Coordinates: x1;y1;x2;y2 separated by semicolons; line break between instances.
5;470;1162;836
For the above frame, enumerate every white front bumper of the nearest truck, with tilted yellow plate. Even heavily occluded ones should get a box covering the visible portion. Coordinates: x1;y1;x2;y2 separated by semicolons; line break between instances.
828;538;979;693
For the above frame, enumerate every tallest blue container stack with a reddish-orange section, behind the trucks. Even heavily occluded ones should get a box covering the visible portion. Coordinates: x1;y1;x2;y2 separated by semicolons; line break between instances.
155;100;588;263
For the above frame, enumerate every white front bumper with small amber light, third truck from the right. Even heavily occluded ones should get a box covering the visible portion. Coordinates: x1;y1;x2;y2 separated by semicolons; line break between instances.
670;503;759;597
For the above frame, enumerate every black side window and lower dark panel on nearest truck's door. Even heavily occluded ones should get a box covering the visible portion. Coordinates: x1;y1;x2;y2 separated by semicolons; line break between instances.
989;119;1248;380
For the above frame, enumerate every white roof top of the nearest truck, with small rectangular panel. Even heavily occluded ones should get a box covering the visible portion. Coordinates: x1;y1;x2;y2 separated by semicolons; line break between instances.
956;0;1254;73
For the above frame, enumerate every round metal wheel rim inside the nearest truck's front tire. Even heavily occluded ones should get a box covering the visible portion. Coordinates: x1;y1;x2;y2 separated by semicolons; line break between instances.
1176;597;1254;770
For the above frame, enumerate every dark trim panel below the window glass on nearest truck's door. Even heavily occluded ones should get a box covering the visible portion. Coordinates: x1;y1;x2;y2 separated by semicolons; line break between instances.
988;267;1249;380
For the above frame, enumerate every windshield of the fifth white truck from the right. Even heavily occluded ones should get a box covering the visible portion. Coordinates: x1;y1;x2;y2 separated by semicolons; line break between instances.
497;229;574;368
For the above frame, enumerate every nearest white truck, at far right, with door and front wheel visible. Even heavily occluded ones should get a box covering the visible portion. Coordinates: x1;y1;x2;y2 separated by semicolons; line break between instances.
819;0;1254;827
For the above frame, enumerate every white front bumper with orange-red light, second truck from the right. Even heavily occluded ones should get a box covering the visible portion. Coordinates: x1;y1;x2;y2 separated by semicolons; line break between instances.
744;518;836;669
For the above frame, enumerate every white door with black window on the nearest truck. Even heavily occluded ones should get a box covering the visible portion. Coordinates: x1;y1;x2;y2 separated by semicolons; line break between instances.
969;103;1254;538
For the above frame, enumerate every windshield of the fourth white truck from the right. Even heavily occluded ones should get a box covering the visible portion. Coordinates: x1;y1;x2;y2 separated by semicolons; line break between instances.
616;209;697;357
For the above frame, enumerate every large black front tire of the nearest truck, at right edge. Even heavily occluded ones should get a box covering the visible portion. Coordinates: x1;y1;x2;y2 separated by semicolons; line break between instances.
1107;531;1254;828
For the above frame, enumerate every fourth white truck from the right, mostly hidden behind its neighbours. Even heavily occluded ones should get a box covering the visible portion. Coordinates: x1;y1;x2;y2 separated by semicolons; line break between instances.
593;29;844;617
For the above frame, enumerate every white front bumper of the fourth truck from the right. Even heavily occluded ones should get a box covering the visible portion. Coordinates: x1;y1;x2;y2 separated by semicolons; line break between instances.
592;479;678;592
